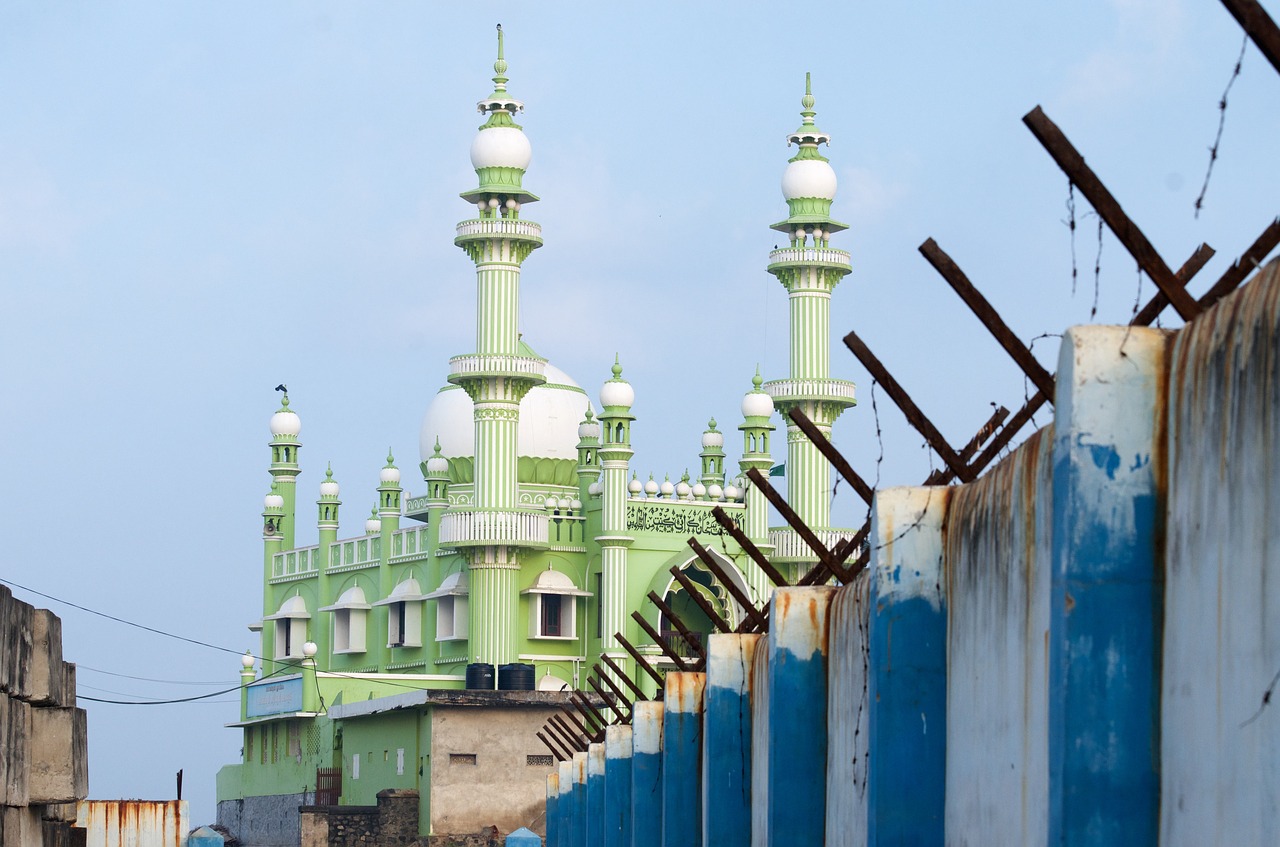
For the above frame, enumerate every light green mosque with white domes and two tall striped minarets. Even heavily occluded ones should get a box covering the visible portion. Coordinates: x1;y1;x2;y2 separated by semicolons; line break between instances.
218;28;854;844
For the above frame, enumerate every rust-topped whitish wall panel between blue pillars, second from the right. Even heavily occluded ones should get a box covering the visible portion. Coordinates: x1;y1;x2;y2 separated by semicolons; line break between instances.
945;426;1053;847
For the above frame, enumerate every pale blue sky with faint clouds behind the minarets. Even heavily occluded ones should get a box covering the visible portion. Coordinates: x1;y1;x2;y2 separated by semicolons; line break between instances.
0;0;1280;825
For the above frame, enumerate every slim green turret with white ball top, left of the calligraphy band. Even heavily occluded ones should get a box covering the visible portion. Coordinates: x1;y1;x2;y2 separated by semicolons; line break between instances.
595;358;636;685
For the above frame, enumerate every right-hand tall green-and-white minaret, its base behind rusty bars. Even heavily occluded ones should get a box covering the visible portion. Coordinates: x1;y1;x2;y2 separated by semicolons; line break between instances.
764;74;854;563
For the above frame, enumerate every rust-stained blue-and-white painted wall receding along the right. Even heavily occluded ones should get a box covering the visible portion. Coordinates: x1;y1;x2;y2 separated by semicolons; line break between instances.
556;260;1280;847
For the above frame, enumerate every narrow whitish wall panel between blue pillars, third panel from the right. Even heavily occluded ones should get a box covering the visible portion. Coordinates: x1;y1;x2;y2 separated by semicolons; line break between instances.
826;571;870;847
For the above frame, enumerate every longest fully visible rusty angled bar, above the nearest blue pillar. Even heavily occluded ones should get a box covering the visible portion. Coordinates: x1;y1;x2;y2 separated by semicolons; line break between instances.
1023;106;1203;322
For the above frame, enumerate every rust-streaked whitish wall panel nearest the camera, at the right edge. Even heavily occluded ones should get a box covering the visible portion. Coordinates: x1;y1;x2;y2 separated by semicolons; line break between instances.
1160;261;1280;847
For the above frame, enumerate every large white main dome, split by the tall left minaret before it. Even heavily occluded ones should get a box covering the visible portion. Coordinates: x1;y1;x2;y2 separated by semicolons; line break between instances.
419;360;588;465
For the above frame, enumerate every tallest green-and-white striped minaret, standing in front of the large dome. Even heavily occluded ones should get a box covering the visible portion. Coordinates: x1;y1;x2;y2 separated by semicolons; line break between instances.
440;26;547;665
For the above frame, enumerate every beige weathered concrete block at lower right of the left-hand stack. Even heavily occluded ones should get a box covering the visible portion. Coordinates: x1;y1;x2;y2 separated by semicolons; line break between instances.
27;706;88;803
